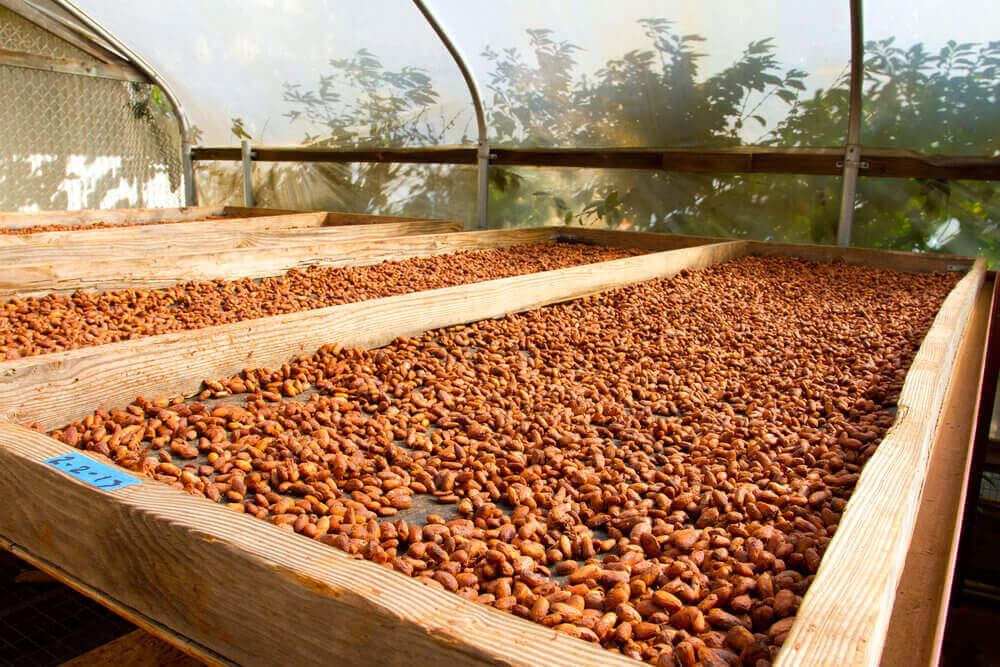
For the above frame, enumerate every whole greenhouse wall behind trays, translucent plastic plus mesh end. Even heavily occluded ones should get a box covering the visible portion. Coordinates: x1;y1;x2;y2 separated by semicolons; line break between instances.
0;0;1000;262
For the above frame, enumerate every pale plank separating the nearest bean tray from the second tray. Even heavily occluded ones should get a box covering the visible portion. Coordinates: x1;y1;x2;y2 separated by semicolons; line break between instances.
0;240;746;428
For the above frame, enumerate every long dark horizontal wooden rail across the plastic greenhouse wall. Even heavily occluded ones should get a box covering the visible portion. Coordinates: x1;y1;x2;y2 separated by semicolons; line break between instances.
191;146;1000;180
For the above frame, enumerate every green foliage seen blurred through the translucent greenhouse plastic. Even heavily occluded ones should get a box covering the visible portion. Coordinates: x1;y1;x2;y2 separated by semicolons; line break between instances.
172;19;1000;262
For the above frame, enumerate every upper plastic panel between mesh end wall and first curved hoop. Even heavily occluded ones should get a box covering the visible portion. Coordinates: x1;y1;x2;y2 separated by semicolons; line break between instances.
77;0;476;146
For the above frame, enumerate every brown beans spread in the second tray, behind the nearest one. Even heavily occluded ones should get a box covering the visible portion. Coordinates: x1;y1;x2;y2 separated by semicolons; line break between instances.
0;241;645;360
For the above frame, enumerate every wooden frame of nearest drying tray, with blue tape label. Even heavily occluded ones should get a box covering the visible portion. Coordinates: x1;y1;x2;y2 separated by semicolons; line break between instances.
0;241;992;665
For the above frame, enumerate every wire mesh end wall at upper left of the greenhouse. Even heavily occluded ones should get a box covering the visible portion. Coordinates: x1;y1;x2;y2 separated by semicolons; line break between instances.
0;8;183;210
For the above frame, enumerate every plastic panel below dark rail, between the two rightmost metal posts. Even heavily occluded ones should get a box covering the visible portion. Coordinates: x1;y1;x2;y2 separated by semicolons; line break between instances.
490;167;840;243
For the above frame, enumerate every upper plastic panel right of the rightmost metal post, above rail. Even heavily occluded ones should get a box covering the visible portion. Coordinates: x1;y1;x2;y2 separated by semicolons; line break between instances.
861;0;1000;156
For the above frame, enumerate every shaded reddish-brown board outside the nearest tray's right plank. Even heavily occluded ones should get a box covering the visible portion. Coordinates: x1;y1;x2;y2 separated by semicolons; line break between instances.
880;283;996;667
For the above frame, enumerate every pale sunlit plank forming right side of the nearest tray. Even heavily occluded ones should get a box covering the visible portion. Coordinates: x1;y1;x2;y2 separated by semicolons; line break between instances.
776;259;986;666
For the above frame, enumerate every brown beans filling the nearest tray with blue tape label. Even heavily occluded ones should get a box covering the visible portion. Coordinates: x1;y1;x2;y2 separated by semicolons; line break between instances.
43;257;956;667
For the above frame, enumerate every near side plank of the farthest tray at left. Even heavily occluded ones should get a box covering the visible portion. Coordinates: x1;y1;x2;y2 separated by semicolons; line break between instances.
0;213;462;264
